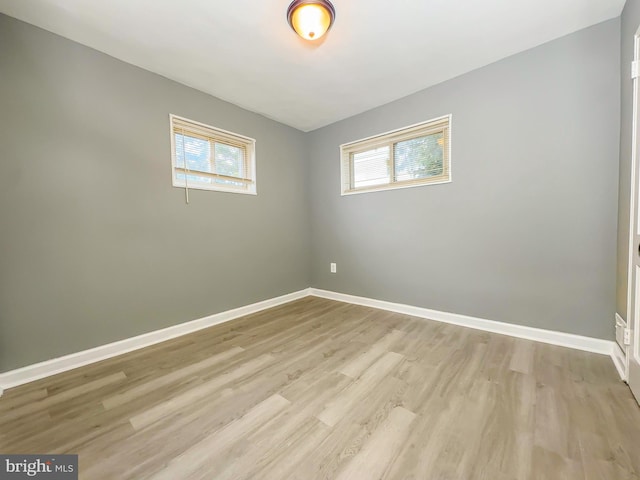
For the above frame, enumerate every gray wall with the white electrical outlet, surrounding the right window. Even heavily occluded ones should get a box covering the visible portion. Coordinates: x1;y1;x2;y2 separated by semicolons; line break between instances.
309;18;620;339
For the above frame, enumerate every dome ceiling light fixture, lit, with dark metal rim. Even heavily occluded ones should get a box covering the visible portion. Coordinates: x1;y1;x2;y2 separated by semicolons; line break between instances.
287;0;336;40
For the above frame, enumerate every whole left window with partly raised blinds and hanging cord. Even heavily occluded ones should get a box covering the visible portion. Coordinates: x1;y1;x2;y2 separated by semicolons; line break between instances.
170;115;256;195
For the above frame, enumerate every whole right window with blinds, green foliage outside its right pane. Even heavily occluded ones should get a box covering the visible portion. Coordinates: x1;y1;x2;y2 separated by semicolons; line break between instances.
340;115;451;195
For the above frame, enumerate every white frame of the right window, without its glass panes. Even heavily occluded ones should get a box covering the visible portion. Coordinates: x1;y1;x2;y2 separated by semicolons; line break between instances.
340;114;452;196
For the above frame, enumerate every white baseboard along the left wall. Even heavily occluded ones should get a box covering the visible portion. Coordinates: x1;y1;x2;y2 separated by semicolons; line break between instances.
0;289;309;395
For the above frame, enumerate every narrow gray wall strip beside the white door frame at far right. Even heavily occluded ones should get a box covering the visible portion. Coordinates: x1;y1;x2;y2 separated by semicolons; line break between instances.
616;0;640;319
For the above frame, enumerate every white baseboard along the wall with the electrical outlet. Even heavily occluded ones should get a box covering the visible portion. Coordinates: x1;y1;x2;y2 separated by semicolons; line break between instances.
309;288;615;356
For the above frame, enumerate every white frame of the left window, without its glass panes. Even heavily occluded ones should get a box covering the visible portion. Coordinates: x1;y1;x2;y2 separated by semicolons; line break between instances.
169;114;258;195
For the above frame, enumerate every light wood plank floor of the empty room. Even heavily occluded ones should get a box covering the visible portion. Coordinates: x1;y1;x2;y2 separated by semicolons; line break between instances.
0;297;640;480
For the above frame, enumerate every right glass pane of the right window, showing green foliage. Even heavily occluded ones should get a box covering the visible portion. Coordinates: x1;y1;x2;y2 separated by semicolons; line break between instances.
393;133;444;182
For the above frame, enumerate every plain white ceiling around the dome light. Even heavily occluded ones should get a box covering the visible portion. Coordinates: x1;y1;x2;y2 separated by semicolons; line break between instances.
0;0;625;131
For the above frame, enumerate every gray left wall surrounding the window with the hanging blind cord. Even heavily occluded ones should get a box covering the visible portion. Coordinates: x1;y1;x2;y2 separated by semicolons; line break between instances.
0;16;309;372
